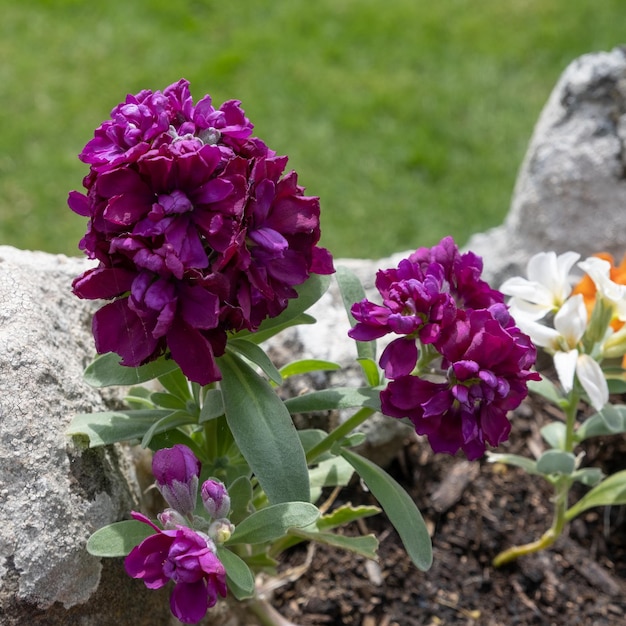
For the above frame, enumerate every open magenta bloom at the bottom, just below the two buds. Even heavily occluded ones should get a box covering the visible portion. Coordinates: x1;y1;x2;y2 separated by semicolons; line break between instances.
124;512;227;624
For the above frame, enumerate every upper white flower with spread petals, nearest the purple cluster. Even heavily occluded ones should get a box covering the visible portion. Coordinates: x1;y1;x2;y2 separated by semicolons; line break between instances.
500;252;580;320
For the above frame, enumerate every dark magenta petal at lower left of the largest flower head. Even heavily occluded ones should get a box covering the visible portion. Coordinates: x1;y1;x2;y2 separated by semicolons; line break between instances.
92;298;157;367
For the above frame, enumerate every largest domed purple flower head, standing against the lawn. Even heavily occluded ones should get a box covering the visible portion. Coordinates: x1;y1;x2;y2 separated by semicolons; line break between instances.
68;79;333;384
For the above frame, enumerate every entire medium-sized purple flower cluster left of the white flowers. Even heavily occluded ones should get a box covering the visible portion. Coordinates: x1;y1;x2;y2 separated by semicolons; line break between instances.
349;237;539;459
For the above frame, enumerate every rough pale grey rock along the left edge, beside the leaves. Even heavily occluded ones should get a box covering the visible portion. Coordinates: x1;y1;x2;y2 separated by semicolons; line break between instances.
0;246;169;626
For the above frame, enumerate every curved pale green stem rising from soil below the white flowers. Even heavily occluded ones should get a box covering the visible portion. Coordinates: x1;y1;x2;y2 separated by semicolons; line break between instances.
492;391;580;567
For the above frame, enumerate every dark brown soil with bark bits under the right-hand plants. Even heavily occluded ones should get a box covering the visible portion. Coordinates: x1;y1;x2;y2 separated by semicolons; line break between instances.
273;394;626;626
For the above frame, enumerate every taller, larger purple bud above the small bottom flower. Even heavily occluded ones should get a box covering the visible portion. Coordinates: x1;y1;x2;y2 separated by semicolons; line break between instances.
152;444;200;515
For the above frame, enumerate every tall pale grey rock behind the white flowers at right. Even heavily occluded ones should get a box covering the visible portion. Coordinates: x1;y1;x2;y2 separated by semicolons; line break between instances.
466;48;626;284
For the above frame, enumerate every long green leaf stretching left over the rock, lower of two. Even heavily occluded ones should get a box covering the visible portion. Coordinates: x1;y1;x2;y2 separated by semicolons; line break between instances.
66;409;172;448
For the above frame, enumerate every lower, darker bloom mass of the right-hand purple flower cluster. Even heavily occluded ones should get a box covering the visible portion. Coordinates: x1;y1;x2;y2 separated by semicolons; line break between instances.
381;304;539;460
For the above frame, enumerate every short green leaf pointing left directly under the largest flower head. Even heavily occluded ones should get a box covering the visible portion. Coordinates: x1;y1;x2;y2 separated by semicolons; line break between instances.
84;352;178;387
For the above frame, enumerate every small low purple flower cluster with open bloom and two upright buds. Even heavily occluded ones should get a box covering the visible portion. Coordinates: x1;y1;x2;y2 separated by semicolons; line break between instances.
124;444;234;624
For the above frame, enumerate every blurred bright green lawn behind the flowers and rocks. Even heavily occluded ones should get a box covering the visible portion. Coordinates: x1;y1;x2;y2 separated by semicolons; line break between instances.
0;0;626;258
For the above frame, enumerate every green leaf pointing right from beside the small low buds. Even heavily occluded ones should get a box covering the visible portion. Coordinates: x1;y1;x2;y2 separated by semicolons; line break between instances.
227;502;320;544
